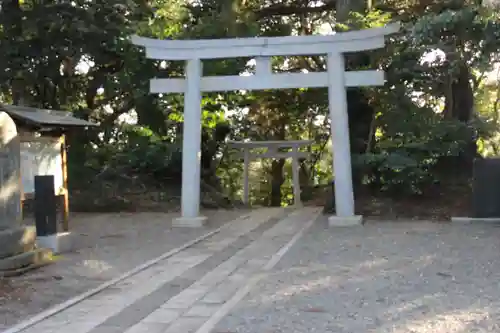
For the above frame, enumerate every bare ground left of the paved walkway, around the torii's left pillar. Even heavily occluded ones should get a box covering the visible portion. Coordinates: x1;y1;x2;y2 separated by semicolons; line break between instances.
0;209;248;331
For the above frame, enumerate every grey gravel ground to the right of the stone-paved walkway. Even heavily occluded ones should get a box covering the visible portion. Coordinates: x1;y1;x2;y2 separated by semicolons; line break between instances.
213;217;500;333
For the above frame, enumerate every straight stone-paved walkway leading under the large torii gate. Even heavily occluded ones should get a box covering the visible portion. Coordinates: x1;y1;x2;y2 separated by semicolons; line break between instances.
9;208;319;333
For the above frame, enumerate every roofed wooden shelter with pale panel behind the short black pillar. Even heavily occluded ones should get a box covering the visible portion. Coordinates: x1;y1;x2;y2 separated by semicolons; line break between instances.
0;105;97;231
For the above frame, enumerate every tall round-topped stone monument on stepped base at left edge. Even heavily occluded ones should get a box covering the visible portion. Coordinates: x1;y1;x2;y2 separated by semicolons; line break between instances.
0;112;51;277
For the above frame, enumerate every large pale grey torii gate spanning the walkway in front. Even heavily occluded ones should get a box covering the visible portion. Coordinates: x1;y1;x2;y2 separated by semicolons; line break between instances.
132;24;399;226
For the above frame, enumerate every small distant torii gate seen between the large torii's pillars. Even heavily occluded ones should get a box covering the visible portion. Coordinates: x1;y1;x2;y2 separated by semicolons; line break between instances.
228;140;314;207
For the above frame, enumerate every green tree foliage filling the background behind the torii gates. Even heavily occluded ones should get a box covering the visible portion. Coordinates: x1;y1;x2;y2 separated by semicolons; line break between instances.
0;0;500;210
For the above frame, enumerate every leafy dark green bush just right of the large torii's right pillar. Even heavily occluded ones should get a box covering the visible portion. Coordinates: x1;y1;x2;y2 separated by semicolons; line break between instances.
353;113;470;194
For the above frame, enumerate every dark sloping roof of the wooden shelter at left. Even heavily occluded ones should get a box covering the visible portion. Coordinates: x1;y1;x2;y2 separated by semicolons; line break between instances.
0;104;97;127
